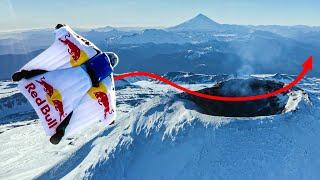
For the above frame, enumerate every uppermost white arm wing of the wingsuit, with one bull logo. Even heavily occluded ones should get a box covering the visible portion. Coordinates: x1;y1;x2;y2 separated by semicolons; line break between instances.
14;24;101;71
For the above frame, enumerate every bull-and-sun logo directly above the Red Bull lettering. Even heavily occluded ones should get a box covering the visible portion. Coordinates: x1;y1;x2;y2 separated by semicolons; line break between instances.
36;77;67;122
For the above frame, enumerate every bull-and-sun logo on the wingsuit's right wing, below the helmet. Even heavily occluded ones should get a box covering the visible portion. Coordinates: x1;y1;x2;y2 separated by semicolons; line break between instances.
88;83;114;119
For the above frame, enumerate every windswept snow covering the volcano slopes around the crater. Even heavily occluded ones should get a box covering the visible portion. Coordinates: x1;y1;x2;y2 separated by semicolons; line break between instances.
0;73;320;180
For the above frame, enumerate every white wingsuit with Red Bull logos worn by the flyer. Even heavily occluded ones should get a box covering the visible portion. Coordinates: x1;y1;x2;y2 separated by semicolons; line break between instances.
13;25;116;144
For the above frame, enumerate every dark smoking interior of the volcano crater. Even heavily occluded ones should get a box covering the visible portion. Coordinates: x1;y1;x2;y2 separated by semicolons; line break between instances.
180;78;289;117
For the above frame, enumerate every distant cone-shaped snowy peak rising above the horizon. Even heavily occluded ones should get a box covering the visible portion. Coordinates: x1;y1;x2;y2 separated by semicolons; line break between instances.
168;14;221;31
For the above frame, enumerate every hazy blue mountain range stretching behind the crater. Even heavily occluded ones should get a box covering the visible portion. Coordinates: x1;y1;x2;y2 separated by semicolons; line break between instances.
0;14;320;79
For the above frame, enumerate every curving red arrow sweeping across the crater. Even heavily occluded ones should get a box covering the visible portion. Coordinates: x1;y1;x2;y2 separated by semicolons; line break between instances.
114;56;313;102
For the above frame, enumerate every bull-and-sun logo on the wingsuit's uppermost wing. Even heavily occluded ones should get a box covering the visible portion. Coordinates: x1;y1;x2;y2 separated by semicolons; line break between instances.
59;33;89;66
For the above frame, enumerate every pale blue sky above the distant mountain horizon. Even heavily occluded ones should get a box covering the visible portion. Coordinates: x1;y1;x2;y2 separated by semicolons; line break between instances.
0;0;320;31
